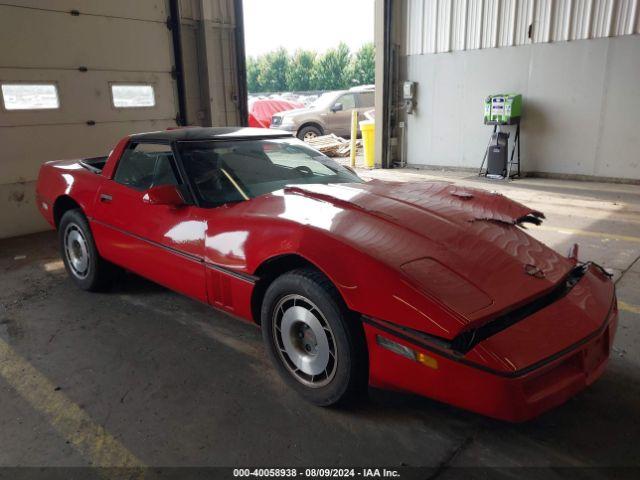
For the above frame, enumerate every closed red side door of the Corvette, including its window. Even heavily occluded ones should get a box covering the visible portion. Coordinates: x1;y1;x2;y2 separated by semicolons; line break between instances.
91;143;207;301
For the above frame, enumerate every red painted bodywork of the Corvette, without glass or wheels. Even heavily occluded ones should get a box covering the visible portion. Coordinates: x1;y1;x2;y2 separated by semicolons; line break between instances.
37;129;617;421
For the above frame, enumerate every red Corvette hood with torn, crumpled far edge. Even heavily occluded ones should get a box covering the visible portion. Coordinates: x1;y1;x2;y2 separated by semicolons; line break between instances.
284;181;575;329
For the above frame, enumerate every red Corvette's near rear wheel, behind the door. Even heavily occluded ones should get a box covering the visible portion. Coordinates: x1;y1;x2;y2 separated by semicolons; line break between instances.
58;209;122;292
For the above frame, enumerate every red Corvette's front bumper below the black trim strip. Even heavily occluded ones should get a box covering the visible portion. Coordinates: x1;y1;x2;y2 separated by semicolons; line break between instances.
364;299;618;422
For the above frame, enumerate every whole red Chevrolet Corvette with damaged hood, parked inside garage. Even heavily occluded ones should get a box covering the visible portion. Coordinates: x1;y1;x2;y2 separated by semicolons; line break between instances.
37;128;617;421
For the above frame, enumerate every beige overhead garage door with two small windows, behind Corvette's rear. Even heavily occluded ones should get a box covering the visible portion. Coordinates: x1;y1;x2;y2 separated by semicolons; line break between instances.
0;0;178;238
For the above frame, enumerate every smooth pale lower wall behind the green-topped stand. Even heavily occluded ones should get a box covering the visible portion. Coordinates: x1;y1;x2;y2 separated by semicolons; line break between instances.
405;35;640;179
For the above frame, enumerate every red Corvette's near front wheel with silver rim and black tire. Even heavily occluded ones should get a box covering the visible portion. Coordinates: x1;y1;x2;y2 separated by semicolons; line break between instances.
261;269;368;407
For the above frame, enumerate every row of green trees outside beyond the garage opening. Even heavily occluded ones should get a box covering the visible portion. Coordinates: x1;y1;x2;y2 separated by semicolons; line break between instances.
247;43;375;93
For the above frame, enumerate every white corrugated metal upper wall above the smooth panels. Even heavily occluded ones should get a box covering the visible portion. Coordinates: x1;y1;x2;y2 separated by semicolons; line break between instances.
406;0;640;55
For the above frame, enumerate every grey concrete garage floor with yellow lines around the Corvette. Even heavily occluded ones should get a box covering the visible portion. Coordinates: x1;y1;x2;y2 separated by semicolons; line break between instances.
0;170;640;478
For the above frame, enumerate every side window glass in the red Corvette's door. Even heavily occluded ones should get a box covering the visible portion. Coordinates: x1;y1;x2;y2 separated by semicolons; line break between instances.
113;143;179;191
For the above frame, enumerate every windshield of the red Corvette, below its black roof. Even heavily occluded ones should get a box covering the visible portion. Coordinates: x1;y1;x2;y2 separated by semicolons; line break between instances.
178;138;362;206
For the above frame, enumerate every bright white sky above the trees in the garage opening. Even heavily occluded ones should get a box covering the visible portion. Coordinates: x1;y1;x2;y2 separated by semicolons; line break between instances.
243;0;374;57
